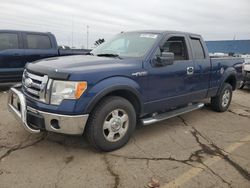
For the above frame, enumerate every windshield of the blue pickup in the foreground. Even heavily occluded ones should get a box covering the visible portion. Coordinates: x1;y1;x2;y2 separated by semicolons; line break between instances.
91;32;159;57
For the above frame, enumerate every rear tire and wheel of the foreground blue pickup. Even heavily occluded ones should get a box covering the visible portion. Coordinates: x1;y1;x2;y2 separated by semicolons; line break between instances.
211;83;233;112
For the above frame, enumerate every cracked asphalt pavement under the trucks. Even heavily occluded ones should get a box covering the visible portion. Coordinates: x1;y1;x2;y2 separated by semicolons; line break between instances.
0;89;250;188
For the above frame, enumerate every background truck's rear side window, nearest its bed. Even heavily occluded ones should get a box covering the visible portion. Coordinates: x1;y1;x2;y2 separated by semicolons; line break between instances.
27;34;52;49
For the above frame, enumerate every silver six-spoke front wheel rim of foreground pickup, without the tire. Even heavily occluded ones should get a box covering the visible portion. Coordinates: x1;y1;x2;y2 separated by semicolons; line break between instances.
103;109;129;142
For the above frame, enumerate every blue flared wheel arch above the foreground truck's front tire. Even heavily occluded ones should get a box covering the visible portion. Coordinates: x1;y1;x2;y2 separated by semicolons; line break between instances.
85;77;143;113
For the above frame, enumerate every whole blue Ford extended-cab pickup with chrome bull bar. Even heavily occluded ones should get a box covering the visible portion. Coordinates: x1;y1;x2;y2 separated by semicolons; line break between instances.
8;31;244;151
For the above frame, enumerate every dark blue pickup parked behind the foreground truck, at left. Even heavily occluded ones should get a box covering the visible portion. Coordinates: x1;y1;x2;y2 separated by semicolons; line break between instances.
0;30;88;86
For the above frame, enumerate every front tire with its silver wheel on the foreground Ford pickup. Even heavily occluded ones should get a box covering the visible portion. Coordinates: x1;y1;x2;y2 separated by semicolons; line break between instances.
86;96;136;151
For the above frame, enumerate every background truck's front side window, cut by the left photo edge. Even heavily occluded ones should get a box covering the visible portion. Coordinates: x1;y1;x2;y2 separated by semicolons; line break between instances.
0;33;18;50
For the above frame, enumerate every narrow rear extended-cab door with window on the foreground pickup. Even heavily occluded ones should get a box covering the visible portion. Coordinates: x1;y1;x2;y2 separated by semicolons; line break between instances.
189;35;211;100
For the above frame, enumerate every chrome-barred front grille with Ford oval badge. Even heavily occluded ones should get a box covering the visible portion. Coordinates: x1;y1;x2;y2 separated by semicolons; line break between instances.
22;70;49;102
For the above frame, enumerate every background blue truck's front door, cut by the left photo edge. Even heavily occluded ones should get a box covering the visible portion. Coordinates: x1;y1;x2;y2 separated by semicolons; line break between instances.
0;31;25;82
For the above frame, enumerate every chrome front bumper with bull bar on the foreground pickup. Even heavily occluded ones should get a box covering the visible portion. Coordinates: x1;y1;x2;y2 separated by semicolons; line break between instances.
8;87;89;135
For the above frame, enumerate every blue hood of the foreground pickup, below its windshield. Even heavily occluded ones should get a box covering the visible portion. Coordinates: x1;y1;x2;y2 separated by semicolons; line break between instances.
26;55;142;79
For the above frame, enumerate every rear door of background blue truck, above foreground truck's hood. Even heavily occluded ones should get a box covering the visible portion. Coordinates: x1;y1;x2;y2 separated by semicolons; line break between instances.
23;33;58;62
